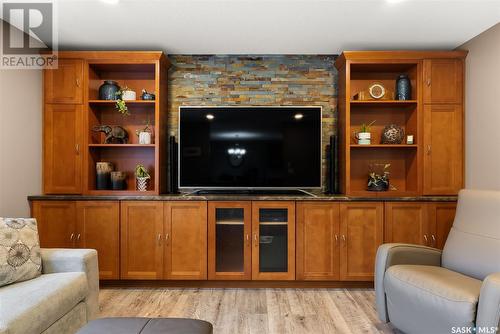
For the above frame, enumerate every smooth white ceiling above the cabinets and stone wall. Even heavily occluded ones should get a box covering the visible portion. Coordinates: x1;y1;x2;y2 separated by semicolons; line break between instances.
56;0;500;54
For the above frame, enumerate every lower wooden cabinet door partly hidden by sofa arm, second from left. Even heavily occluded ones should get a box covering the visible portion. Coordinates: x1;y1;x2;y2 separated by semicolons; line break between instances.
76;201;120;279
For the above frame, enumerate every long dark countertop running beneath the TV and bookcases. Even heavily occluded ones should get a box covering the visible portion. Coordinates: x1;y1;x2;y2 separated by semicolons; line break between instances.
28;194;457;202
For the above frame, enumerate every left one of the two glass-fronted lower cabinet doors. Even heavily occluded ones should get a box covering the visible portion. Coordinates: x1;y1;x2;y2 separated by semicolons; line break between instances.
208;202;252;280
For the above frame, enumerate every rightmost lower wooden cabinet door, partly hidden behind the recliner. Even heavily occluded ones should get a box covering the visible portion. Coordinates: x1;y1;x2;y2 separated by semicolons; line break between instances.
427;203;457;249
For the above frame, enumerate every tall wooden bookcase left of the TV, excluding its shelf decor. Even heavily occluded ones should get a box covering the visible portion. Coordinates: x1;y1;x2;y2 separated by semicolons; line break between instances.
44;51;169;195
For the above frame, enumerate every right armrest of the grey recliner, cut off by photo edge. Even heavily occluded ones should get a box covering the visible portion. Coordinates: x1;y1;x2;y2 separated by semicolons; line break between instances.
476;273;500;333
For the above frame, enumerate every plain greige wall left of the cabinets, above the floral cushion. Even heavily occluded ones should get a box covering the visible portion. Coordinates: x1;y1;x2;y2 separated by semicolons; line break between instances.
0;70;42;217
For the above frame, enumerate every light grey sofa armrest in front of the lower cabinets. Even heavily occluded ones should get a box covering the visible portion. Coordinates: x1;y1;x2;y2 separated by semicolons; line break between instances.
40;248;99;321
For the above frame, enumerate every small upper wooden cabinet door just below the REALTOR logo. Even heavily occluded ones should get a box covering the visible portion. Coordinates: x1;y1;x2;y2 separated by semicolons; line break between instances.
44;59;83;104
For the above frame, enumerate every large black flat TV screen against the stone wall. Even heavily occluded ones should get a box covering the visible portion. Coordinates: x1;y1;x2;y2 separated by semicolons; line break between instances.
179;107;321;189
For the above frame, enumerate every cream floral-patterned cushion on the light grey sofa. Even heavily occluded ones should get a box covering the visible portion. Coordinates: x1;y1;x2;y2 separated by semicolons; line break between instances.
0;218;42;287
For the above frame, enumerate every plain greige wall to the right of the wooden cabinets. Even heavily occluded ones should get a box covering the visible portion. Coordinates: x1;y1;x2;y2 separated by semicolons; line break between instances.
460;24;500;190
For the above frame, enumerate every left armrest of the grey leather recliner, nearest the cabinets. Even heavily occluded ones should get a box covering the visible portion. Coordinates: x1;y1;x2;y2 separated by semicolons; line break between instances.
375;243;442;322
